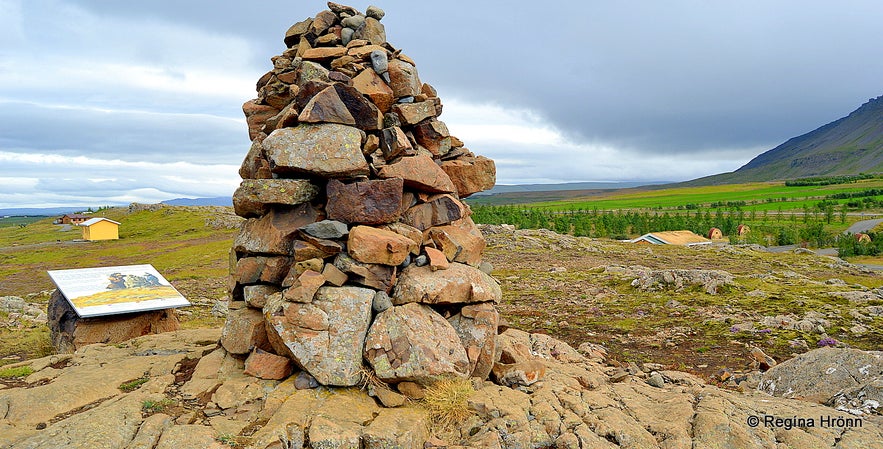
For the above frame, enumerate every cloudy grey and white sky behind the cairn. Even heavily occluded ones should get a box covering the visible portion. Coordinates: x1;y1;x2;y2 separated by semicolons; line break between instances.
0;0;883;208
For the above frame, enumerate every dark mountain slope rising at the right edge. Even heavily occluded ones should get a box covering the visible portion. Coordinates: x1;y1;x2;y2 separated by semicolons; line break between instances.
679;96;883;185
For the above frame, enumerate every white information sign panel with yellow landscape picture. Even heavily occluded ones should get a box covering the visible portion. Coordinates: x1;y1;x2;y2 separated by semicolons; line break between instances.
48;265;190;318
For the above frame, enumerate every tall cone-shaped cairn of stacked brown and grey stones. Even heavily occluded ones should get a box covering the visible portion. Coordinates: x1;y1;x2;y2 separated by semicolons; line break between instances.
221;3;501;390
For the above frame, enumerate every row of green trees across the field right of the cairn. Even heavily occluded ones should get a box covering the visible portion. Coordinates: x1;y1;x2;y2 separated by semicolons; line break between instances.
472;206;846;246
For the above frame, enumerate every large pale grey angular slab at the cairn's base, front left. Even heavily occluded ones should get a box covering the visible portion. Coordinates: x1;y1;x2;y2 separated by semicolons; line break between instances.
265;287;374;386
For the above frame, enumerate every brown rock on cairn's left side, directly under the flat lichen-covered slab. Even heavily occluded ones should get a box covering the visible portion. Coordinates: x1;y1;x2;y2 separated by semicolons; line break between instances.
233;203;320;256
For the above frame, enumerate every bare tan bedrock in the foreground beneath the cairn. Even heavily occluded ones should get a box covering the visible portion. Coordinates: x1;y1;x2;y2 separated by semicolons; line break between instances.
0;329;883;449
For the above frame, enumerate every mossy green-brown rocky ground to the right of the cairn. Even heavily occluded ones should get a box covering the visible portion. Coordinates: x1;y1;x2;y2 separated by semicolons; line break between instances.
482;225;883;386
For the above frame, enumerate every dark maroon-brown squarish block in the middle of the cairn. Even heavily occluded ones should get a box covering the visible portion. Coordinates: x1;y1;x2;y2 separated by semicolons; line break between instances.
325;178;404;225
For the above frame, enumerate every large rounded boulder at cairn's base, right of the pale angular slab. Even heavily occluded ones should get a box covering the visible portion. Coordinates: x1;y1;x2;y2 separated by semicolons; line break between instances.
365;303;470;385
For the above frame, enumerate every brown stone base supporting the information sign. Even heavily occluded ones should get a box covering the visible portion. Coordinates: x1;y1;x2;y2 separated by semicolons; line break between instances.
47;290;181;353
